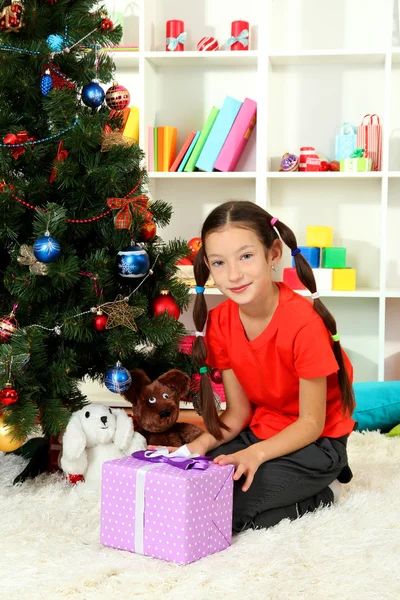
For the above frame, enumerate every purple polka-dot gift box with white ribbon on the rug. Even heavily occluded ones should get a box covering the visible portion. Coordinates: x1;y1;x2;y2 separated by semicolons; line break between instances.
100;453;234;565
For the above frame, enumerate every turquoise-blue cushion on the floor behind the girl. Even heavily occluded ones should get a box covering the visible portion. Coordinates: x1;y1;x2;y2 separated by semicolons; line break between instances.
353;381;400;433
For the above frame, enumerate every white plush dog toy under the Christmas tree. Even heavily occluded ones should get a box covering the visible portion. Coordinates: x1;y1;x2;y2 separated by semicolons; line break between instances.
61;404;147;489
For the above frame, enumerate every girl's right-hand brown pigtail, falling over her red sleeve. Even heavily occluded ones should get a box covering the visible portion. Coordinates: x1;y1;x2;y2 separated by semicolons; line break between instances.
273;219;355;415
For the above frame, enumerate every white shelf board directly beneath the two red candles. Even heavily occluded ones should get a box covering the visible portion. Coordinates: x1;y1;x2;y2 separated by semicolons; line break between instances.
144;50;258;67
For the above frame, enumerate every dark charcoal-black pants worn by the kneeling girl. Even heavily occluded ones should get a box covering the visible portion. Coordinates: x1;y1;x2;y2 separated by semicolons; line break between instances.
208;429;353;533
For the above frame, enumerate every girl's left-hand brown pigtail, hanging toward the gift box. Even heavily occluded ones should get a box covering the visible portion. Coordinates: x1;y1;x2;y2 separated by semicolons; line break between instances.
192;246;229;440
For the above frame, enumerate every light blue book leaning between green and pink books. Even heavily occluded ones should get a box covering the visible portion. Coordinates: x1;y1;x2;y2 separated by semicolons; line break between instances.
196;96;242;172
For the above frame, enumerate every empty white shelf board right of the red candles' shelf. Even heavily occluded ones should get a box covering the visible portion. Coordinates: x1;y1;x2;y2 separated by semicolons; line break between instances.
269;50;386;66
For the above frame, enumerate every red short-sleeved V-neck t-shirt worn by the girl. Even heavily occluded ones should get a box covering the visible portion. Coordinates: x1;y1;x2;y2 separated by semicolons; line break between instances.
205;283;354;439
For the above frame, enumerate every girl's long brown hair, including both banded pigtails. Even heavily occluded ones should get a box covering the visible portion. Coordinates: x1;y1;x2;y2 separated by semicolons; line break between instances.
193;200;355;440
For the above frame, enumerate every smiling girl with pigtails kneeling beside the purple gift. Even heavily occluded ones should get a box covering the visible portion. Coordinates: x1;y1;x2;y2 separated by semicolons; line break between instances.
183;201;355;532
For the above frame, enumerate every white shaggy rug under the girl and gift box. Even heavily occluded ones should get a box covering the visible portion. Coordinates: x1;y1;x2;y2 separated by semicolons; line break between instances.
0;432;400;600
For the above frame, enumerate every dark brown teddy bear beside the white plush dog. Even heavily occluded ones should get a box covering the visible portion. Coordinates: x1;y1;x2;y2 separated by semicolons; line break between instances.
123;369;203;447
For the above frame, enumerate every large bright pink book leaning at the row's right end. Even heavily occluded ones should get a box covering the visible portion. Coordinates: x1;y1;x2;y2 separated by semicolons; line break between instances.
214;98;257;172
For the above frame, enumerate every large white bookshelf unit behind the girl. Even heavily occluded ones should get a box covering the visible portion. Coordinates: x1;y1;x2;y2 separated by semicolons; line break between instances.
94;0;400;394
